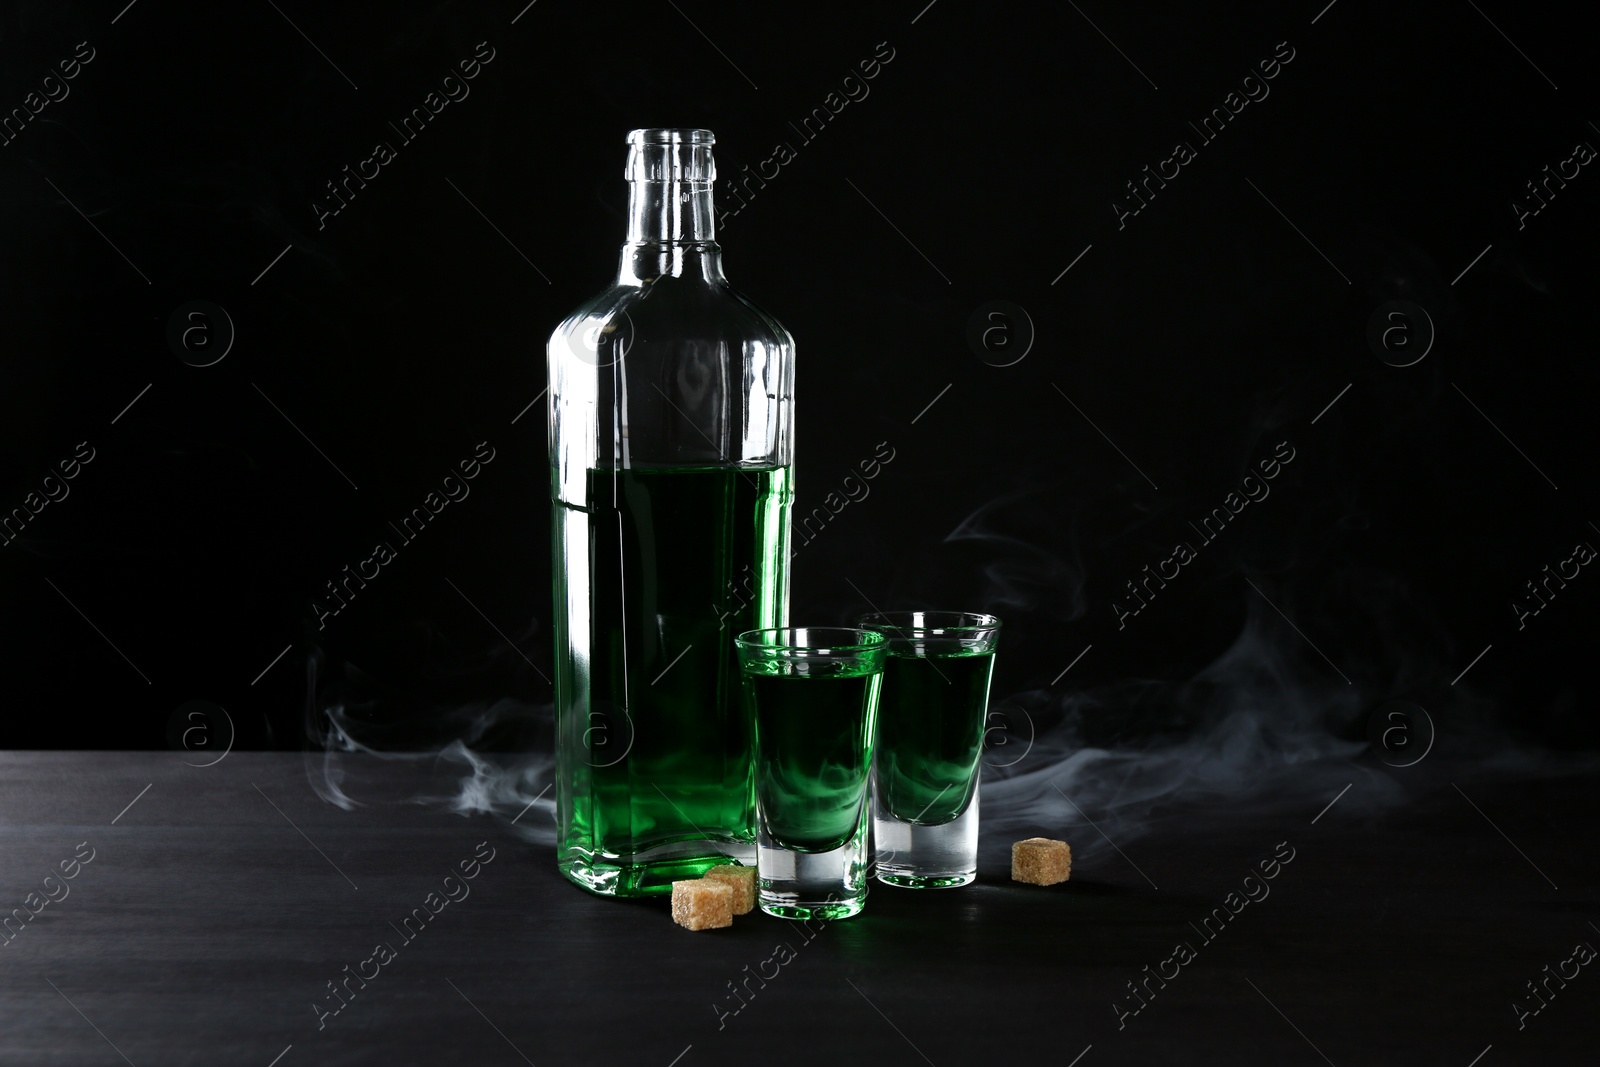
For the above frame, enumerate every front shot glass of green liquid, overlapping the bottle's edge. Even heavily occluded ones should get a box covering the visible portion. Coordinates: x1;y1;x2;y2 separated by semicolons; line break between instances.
736;627;888;918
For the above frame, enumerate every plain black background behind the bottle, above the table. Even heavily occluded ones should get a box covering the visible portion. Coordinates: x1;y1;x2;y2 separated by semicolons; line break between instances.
0;0;1600;749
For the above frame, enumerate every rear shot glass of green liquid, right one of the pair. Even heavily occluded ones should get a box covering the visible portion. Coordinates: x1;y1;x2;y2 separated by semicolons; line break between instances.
859;611;1000;889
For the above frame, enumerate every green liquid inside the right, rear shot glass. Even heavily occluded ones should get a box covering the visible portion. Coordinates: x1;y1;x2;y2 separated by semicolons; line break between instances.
877;649;995;825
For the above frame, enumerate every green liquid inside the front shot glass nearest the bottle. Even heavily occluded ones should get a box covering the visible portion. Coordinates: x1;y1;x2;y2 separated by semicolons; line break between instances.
744;670;882;853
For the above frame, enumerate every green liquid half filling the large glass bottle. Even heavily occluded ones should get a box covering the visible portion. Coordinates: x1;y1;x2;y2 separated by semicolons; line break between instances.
554;467;792;896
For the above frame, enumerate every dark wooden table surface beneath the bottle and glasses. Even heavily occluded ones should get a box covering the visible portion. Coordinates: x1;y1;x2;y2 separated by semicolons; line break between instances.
0;752;1600;1067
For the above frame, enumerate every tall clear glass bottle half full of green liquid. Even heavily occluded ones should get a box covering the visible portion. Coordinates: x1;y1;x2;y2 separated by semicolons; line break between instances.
547;130;794;896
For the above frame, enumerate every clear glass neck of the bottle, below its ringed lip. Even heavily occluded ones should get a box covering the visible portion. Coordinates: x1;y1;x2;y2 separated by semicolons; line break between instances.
618;179;723;285
